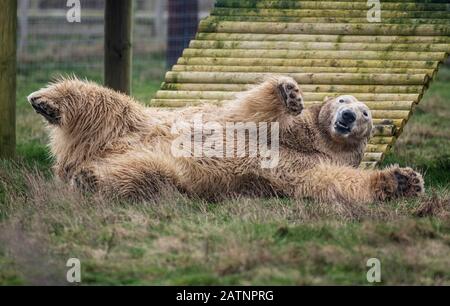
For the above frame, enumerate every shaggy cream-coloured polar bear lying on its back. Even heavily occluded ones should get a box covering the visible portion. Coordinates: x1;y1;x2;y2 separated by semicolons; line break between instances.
28;77;424;203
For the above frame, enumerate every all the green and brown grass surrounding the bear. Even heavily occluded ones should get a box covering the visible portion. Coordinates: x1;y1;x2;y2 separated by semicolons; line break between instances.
0;63;450;285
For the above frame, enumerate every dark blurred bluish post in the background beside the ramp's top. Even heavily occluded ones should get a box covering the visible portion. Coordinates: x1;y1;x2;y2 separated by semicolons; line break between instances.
167;0;198;68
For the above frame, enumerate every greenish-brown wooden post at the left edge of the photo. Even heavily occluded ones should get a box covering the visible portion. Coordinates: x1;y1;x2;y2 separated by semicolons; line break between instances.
0;0;17;158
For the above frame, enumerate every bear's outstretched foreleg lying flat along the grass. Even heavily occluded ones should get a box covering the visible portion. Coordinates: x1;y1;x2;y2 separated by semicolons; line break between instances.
258;164;424;203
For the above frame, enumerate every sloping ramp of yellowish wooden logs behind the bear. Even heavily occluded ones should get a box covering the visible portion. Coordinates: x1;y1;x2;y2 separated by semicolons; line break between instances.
151;0;450;168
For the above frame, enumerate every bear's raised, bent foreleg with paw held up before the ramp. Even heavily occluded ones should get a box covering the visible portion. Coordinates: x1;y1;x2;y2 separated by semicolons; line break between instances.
225;76;304;123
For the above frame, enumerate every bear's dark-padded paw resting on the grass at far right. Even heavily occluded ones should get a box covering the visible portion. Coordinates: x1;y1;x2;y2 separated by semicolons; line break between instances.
378;167;425;200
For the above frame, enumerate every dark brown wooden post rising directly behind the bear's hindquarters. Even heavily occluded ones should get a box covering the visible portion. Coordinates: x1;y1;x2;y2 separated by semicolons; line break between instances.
104;0;133;94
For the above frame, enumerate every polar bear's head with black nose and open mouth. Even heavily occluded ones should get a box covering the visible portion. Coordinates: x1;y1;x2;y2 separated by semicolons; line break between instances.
319;95;373;145
